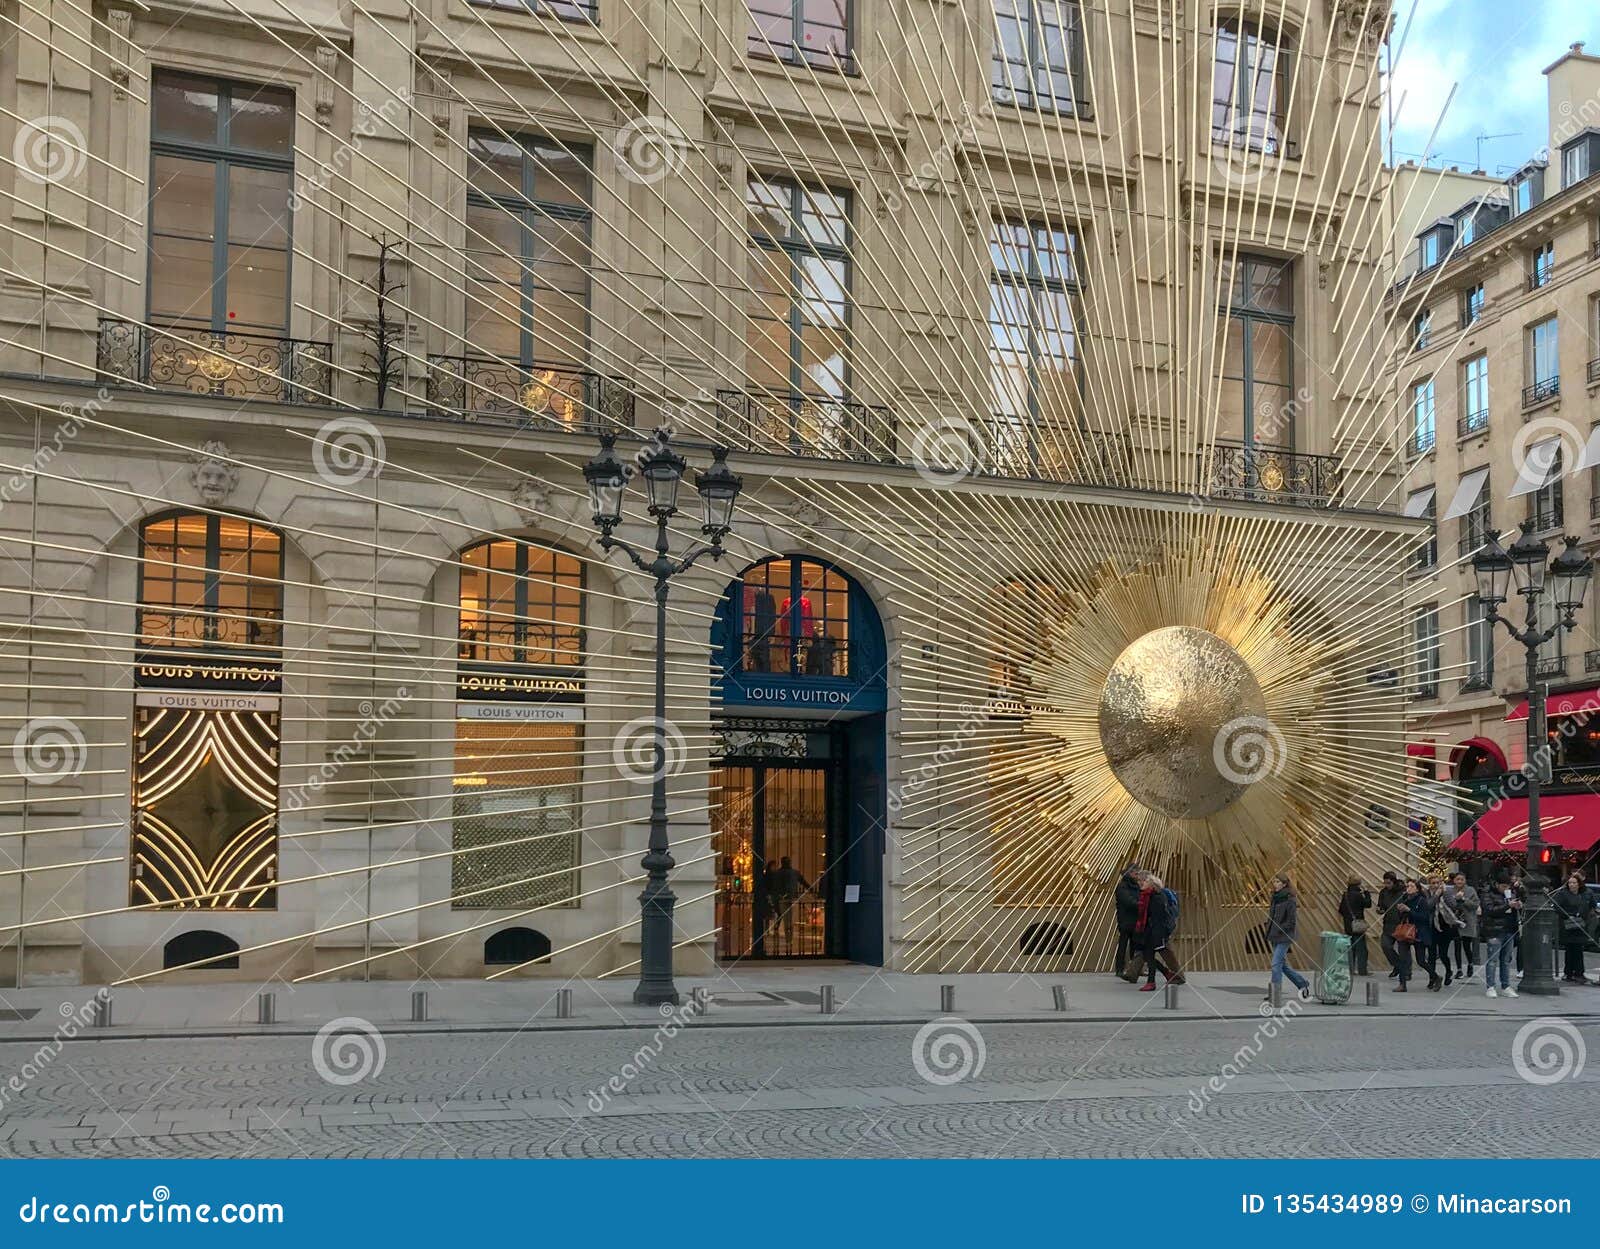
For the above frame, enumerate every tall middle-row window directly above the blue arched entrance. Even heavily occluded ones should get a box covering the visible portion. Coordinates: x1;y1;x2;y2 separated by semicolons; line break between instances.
744;176;851;398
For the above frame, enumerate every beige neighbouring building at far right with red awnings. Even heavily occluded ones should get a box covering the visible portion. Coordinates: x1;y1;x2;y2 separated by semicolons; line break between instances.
1389;45;1600;869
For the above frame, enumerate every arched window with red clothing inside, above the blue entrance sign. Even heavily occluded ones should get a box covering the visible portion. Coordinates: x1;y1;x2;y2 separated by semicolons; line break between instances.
738;558;851;676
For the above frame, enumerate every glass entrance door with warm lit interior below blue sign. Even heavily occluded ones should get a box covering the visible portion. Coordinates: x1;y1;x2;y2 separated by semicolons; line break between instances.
710;760;838;960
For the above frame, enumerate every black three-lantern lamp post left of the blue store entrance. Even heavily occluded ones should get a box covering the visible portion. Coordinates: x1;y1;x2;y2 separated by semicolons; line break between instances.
584;430;744;1006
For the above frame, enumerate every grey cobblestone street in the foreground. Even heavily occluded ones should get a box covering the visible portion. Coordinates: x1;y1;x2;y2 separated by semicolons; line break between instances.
0;1016;1600;1158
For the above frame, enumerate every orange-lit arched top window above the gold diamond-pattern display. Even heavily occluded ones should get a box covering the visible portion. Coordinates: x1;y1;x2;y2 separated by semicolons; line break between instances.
139;512;283;656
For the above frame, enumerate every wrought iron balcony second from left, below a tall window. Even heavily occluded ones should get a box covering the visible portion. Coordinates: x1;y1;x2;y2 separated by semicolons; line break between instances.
427;355;637;433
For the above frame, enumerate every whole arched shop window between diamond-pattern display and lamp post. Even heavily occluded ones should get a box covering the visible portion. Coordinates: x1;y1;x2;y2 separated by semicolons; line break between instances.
451;539;584;908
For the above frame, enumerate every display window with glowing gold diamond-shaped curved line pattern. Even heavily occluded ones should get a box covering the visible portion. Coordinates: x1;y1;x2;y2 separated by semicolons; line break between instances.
128;707;278;910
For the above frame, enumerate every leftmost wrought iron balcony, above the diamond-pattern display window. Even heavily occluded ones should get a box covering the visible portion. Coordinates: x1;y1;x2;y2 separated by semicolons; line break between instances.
94;318;333;403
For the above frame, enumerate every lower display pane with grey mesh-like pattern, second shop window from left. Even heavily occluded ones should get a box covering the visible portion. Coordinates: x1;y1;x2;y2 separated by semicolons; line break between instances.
450;720;582;910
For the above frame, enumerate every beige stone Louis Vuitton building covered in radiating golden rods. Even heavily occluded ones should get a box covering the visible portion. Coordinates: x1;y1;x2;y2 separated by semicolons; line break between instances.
0;0;1408;982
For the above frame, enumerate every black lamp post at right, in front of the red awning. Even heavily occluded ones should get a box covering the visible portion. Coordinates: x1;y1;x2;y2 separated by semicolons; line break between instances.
1472;529;1594;996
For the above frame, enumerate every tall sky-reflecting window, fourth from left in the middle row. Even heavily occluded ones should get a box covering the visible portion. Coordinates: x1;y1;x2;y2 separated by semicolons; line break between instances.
989;221;1080;470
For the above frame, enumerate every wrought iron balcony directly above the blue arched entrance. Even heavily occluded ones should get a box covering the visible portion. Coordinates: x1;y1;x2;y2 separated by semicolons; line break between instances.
717;390;899;464
